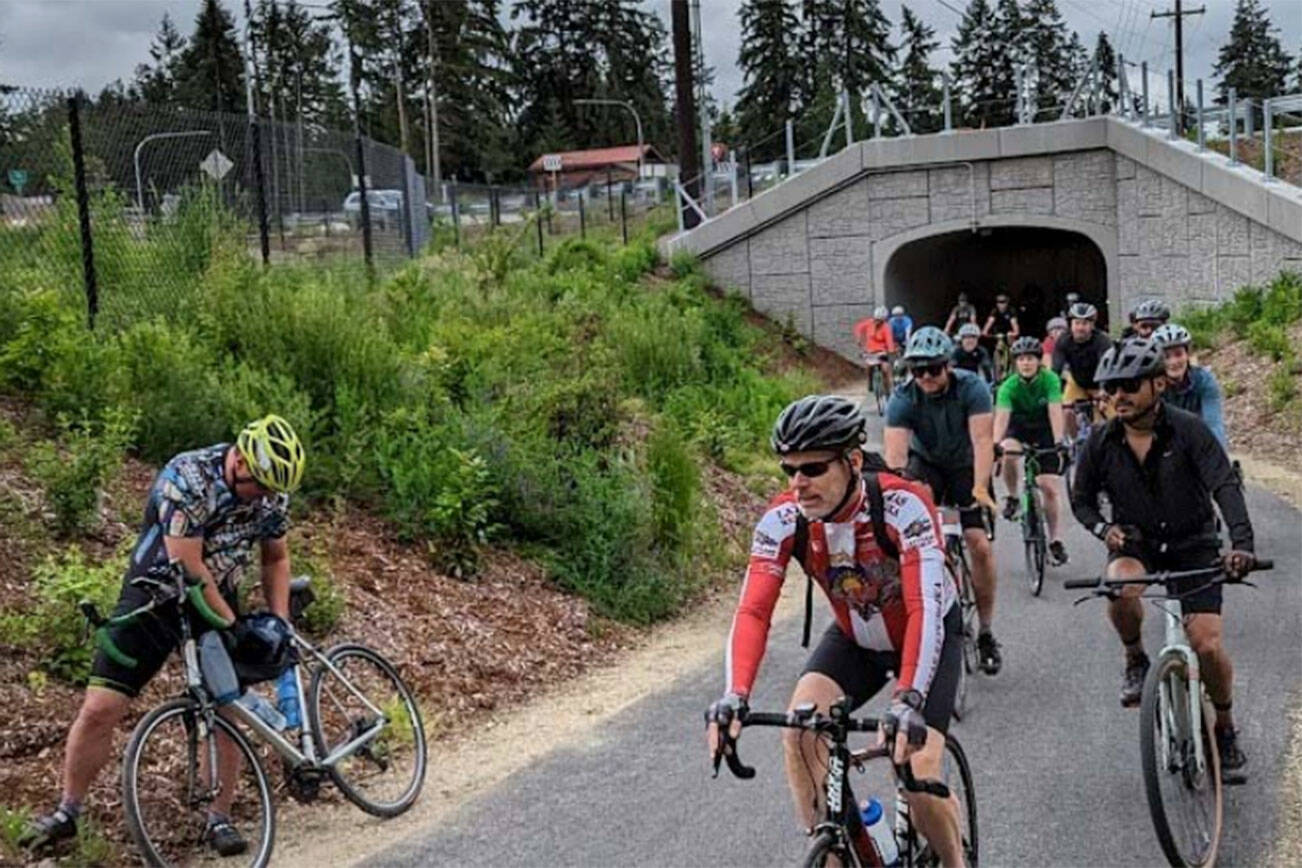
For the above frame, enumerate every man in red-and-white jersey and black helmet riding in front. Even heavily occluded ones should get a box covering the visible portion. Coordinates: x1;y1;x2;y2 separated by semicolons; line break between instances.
707;394;963;865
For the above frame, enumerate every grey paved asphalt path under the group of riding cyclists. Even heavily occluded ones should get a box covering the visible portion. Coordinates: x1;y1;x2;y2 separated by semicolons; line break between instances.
366;411;1302;868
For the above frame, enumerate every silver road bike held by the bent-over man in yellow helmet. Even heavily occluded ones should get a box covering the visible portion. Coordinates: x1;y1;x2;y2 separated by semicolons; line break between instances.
78;569;427;868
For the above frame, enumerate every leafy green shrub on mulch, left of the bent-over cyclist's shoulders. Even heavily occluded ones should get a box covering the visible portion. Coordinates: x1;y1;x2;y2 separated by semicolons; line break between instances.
27;407;135;535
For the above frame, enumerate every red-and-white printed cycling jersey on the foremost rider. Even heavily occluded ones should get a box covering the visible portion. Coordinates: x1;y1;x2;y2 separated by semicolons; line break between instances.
725;474;957;696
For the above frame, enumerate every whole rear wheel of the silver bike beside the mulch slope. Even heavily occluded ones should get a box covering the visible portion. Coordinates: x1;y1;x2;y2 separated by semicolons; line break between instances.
309;645;428;817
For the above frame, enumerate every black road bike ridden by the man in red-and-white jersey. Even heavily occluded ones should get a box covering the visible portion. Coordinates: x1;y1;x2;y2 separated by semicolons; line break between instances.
713;696;978;868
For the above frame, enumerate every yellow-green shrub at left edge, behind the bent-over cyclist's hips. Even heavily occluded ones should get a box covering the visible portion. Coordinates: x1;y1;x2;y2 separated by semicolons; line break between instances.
0;547;128;686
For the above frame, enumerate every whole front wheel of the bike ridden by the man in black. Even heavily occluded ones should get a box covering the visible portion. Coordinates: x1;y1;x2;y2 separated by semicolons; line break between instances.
1139;653;1223;867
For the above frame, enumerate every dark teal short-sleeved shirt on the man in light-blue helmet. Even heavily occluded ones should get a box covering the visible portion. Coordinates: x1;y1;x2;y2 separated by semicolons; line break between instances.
887;370;992;470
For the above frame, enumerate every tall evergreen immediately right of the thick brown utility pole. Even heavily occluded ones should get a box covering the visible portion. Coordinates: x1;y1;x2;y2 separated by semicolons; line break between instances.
737;0;802;160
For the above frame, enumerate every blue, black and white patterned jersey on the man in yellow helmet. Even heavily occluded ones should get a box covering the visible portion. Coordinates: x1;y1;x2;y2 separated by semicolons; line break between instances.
126;444;289;590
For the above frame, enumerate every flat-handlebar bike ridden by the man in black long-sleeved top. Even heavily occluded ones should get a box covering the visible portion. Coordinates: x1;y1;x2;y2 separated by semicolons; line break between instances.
1062;560;1275;868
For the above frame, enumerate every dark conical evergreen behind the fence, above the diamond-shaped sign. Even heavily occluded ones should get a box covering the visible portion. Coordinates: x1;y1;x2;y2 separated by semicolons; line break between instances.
174;0;245;112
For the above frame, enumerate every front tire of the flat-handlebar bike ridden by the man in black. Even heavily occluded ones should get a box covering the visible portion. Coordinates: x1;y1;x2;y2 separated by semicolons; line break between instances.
1139;653;1224;868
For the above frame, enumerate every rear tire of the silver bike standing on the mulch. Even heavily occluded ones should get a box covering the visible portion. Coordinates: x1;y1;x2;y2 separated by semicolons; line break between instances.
307;644;428;817
